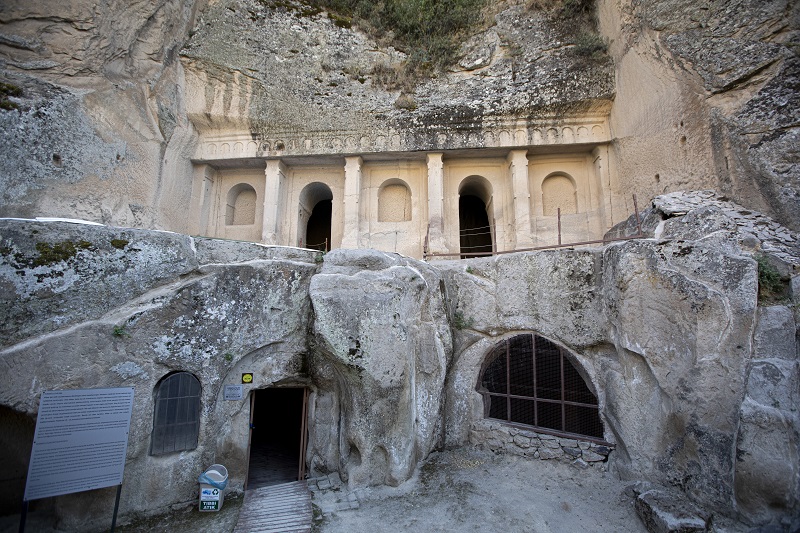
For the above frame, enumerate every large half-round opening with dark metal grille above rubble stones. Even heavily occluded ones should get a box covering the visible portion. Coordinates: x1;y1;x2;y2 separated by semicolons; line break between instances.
478;334;603;440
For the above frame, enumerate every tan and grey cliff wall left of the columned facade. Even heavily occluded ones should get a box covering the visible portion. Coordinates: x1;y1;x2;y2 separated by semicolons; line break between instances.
0;0;206;227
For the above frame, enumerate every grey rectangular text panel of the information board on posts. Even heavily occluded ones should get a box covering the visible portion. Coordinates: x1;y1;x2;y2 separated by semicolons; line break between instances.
24;387;133;502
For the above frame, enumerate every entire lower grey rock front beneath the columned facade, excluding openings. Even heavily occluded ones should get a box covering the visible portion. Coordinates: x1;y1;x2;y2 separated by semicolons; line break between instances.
0;192;800;529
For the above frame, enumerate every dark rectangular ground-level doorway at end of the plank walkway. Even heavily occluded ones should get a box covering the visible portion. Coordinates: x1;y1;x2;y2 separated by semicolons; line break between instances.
245;388;308;490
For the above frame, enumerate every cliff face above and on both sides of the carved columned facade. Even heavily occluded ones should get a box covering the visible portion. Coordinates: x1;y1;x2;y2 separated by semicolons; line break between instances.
0;0;800;231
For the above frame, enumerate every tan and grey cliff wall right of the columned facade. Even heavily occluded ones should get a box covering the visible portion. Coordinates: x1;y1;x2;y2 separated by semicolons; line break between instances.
598;0;800;230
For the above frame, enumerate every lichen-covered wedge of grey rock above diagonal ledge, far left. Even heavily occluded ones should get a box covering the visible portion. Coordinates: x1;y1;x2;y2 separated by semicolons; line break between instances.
0;220;197;347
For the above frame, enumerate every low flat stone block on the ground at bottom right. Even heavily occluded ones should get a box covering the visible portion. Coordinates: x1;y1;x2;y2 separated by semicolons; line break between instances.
634;489;708;533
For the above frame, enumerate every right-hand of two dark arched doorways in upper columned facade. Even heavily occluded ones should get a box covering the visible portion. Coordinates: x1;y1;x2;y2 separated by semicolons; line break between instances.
458;176;494;259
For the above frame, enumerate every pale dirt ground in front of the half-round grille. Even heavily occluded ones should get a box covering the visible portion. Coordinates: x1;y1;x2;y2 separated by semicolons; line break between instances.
315;448;646;533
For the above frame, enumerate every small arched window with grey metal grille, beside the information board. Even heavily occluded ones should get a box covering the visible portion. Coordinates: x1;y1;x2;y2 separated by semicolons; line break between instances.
150;372;200;455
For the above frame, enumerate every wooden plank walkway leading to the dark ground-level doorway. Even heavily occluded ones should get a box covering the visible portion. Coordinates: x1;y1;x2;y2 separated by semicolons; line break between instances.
233;481;311;533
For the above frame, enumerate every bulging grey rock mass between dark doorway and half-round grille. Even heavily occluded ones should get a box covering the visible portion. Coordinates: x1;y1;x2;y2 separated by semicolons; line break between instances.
310;250;452;487
